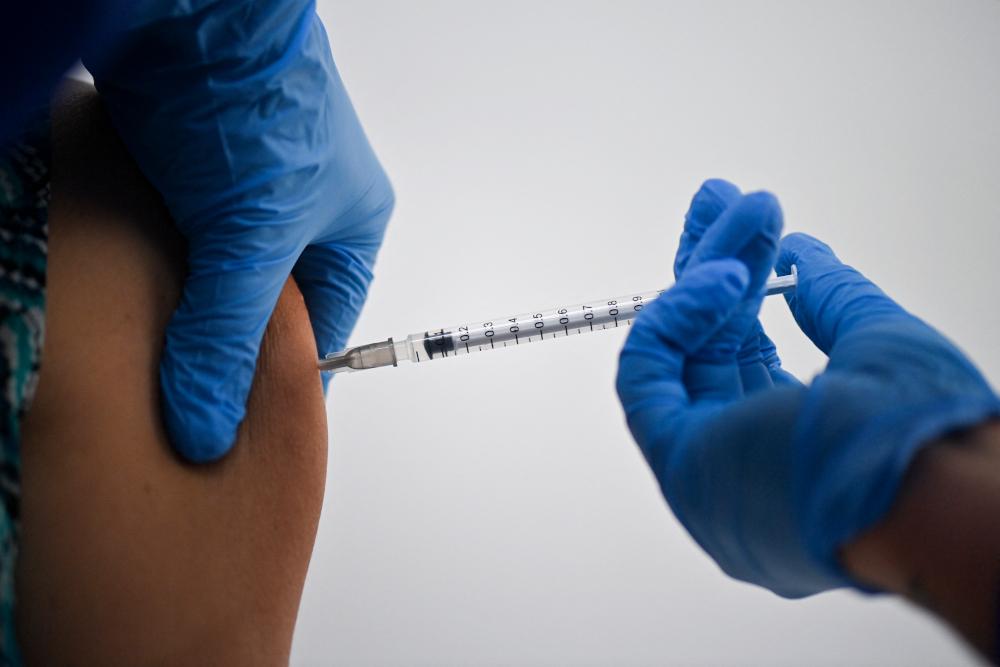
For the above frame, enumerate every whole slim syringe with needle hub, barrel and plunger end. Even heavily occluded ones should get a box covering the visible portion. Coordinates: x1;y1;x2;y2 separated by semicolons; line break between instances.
319;266;798;373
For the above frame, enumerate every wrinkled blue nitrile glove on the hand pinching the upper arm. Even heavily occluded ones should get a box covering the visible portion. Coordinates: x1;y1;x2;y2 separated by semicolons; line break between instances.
85;0;393;461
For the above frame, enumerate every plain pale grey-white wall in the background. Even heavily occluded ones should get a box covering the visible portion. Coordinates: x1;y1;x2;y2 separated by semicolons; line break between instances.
292;0;1000;667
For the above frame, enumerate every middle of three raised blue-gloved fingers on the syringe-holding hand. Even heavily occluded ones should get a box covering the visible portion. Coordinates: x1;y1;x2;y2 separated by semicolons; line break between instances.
685;192;784;365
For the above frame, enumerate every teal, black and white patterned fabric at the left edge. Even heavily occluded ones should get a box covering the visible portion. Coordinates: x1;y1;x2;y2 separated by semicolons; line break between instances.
0;108;51;666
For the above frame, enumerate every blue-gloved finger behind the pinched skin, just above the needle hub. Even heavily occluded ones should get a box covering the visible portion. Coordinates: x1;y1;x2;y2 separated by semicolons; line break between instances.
292;240;381;391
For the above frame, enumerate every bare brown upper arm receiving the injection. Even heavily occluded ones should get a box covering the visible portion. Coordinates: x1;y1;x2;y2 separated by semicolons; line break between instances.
16;82;327;665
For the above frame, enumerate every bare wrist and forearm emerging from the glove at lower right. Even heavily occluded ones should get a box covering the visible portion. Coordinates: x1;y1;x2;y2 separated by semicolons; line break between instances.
841;421;1000;659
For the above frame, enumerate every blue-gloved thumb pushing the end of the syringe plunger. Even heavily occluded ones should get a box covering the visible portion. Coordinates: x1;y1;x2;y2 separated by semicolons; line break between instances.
776;233;908;355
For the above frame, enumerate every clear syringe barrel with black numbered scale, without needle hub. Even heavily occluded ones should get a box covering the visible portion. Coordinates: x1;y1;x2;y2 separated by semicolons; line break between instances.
396;291;660;362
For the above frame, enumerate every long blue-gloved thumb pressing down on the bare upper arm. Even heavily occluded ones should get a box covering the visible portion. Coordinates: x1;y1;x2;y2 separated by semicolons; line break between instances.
160;234;297;462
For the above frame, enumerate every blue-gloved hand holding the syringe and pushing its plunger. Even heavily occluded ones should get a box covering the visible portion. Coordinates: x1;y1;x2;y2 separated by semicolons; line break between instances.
618;184;1000;597
